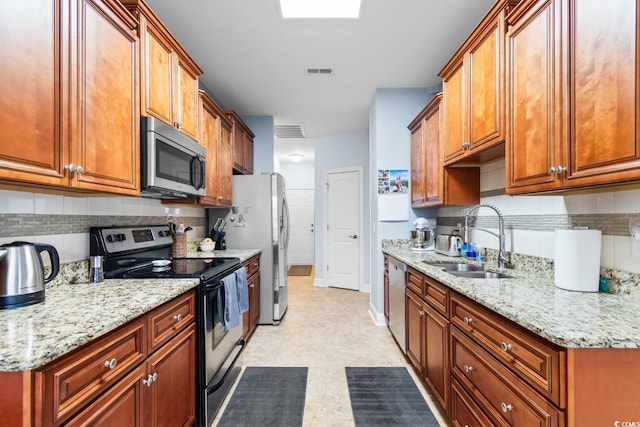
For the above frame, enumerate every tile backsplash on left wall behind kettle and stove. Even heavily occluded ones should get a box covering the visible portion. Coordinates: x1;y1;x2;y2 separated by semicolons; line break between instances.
0;190;207;265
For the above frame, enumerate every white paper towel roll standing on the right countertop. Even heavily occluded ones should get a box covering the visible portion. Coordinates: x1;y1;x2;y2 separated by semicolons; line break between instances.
555;230;602;292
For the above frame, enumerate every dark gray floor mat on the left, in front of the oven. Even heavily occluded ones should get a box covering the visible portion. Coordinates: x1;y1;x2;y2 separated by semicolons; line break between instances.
217;367;309;427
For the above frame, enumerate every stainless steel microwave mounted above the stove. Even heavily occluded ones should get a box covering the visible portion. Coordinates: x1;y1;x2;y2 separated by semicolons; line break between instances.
140;117;206;199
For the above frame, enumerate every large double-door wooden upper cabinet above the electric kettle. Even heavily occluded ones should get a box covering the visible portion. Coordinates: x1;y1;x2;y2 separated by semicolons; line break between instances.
0;0;140;195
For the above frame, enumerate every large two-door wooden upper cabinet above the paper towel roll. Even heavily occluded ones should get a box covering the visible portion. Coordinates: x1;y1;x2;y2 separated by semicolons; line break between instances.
507;0;640;194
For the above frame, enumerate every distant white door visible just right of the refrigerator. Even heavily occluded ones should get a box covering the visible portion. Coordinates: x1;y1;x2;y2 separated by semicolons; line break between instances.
287;189;315;265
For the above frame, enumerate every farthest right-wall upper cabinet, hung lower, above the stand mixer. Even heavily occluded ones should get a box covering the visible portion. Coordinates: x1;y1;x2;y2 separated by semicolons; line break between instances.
409;94;480;208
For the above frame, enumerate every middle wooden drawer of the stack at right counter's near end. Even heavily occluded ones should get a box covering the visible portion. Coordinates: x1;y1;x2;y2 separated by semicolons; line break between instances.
451;328;564;427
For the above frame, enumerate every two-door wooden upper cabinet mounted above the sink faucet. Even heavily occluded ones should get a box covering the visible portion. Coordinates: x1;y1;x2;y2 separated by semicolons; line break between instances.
440;0;517;165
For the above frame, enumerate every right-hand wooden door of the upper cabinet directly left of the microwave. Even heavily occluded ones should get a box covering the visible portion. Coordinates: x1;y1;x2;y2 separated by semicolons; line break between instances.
71;0;140;195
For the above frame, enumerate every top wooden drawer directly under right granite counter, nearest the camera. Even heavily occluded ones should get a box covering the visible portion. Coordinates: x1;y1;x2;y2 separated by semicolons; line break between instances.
451;294;566;408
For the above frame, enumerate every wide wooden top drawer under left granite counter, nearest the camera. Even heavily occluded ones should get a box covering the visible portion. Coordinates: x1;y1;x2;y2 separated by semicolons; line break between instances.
36;318;146;426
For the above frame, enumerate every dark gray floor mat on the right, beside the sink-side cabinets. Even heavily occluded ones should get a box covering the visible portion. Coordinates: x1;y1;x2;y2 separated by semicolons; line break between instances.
345;367;440;427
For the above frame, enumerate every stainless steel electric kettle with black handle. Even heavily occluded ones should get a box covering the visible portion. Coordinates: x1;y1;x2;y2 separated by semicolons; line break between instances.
0;242;60;309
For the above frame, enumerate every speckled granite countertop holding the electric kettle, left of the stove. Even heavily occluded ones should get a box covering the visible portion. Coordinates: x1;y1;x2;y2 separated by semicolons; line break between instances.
0;279;199;371
